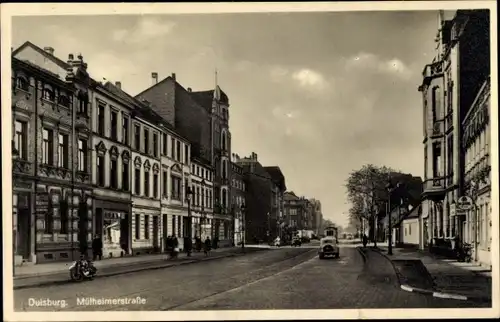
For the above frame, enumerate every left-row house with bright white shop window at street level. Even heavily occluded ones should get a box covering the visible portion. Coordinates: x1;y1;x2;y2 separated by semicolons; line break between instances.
91;82;135;257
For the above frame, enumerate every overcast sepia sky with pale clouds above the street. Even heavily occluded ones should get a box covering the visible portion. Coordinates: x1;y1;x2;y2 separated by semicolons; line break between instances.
13;11;438;225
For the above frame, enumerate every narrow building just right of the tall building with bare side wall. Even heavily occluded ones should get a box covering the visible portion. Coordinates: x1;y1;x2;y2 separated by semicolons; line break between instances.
231;153;246;245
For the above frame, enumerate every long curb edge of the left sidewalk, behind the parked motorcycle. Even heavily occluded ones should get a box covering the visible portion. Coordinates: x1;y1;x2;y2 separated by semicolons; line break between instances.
13;249;261;290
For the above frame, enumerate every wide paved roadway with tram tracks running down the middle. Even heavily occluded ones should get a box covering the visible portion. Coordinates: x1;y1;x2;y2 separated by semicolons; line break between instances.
14;247;480;311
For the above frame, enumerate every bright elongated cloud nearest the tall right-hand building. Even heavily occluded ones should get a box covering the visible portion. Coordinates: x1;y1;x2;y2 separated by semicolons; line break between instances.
344;52;412;79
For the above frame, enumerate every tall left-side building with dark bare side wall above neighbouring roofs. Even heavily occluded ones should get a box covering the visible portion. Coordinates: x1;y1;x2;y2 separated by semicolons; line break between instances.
136;73;231;246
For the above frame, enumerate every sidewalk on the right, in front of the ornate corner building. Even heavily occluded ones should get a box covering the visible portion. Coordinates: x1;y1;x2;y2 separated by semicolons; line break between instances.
380;247;492;302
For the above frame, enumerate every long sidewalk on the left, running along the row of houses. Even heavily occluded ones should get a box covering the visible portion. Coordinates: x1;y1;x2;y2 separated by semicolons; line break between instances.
13;247;263;289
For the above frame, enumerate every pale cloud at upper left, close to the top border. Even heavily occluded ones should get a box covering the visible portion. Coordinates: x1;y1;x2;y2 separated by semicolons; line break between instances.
112;17;177;43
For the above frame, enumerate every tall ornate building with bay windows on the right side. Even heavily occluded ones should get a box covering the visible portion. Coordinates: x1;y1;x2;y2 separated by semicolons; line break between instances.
419;10;490;264
